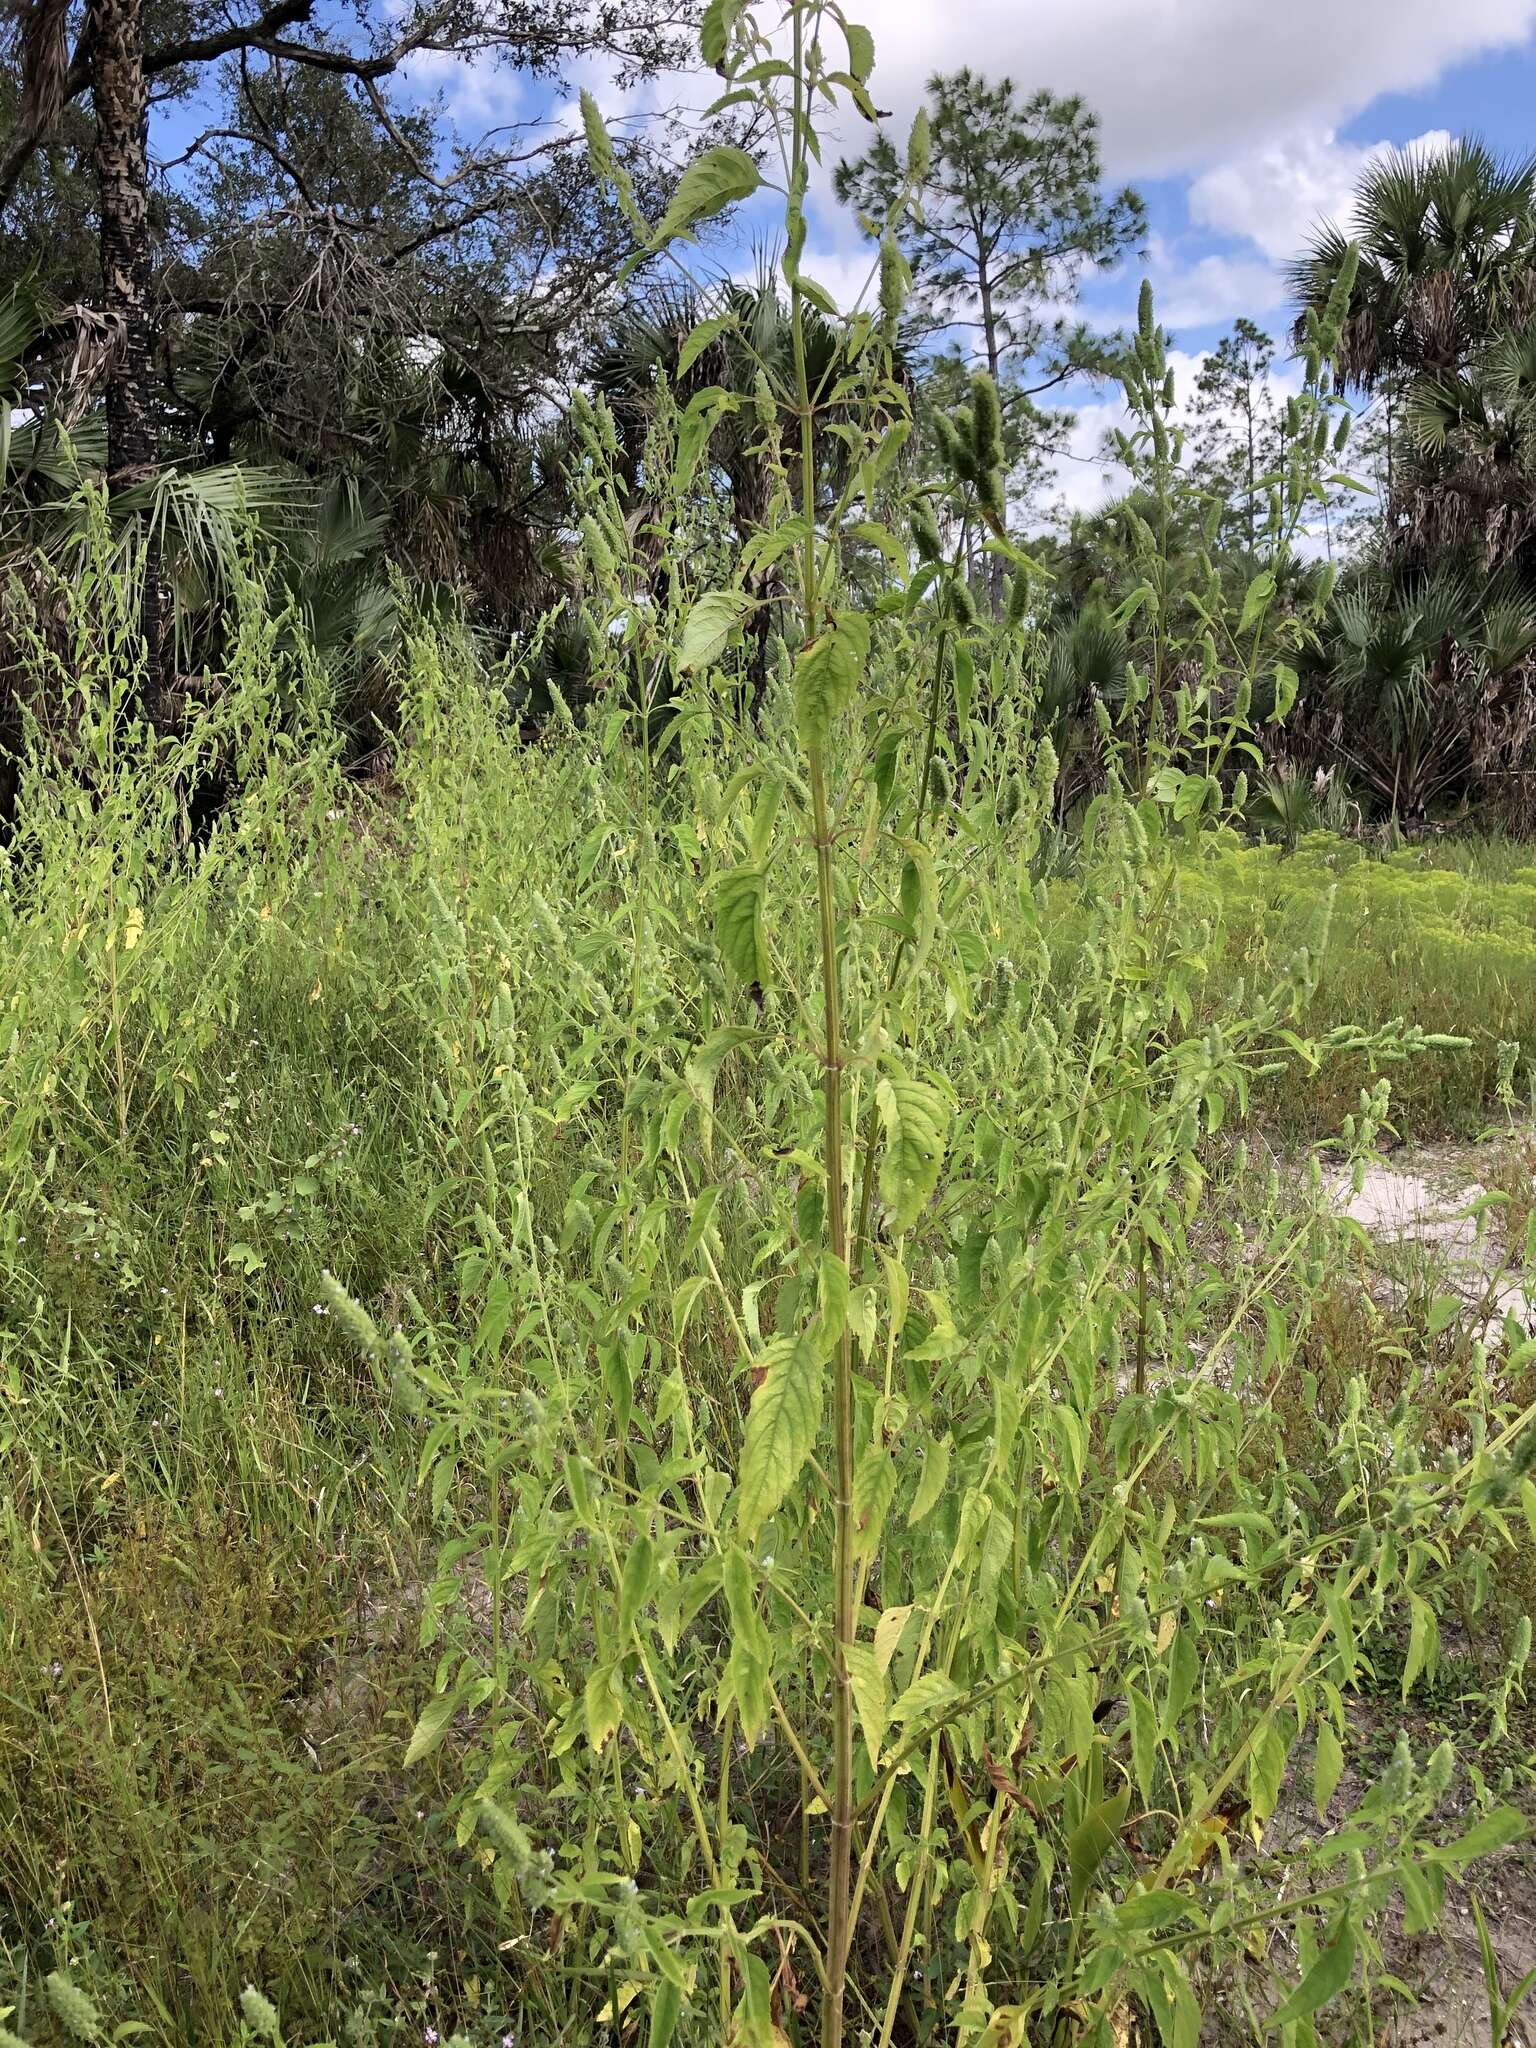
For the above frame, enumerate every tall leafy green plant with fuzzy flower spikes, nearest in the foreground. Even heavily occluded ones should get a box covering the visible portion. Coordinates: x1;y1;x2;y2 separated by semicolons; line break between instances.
315;0;1536;2048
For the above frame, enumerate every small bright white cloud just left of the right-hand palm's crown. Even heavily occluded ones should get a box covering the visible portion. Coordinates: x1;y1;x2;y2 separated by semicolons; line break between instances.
1190;129;1450;260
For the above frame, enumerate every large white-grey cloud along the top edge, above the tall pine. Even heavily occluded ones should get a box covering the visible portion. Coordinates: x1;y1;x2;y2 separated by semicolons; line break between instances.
860;0;1536;178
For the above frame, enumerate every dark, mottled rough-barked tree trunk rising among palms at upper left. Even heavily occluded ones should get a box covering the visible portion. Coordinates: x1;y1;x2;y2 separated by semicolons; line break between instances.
92;0;166;717
